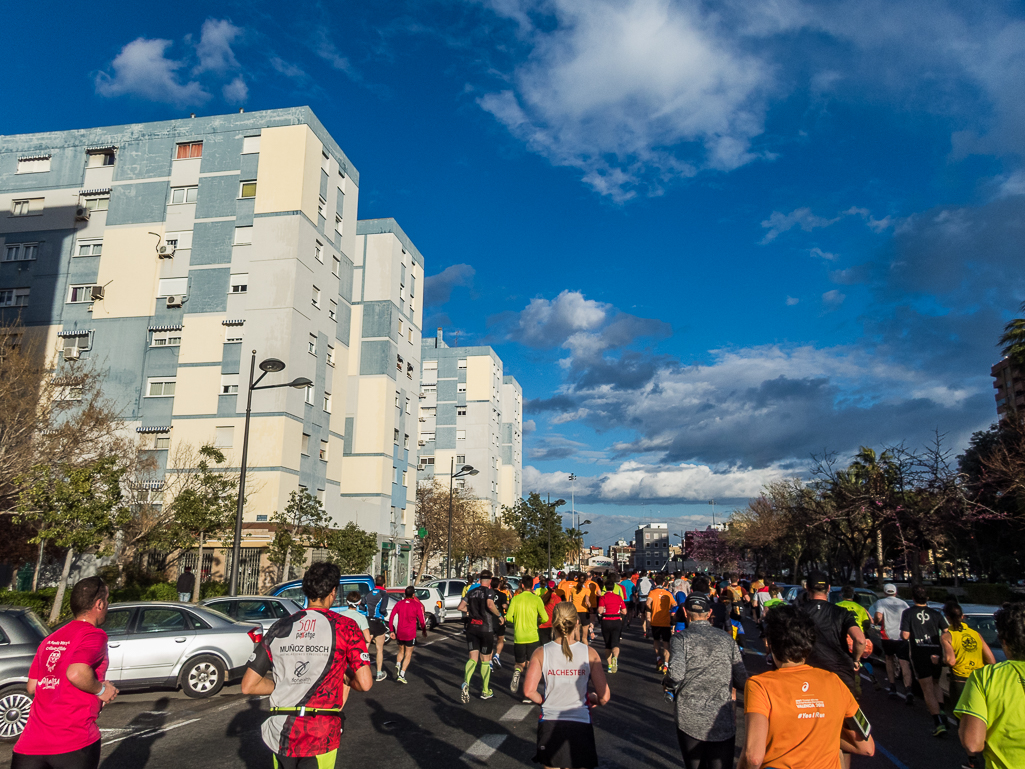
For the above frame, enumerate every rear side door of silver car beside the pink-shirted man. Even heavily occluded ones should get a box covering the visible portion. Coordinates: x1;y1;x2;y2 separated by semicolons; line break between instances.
121;606;196;681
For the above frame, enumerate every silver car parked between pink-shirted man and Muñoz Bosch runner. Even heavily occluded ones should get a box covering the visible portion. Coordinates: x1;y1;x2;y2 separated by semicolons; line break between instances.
103;601;263;698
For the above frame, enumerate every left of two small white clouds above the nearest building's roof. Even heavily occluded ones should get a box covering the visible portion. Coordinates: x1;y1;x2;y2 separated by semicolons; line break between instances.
95;38;210;107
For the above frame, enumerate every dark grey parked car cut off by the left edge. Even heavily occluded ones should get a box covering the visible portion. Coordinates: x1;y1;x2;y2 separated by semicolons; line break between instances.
0;606;50;740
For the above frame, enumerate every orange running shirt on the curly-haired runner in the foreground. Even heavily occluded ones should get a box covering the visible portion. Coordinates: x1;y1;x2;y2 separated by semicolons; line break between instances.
744;664;858;769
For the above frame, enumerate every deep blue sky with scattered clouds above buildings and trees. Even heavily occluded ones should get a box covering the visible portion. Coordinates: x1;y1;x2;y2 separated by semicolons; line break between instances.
0;0;1025;545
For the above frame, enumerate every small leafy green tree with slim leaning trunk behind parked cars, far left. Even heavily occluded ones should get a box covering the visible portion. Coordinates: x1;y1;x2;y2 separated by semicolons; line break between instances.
18;456;130;622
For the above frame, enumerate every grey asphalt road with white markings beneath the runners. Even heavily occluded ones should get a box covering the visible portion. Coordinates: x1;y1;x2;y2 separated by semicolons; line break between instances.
0;623;984;769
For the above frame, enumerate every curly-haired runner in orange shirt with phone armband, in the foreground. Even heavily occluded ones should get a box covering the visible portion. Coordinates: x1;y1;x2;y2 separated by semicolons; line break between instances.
737;606;875;769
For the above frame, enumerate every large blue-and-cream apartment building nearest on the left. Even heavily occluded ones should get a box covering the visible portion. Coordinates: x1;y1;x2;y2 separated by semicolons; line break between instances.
0;108;423;591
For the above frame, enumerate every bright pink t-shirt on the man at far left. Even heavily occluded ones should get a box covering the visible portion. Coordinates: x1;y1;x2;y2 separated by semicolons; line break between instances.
14;619;107;756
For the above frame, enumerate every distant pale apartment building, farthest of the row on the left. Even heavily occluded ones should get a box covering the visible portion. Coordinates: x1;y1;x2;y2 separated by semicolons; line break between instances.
417;328;523;517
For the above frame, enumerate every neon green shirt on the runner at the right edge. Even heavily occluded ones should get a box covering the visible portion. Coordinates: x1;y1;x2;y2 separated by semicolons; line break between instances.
954;659;1025;769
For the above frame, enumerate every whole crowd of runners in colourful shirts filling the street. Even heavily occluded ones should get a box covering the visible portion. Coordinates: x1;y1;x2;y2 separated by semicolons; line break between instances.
11;563;1025;769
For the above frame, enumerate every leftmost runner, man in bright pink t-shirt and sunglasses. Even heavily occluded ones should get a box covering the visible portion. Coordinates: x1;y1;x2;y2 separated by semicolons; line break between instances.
10;576;118;769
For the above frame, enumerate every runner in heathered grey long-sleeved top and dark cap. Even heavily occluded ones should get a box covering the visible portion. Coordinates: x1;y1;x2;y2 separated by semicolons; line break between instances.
662;593;747;769
